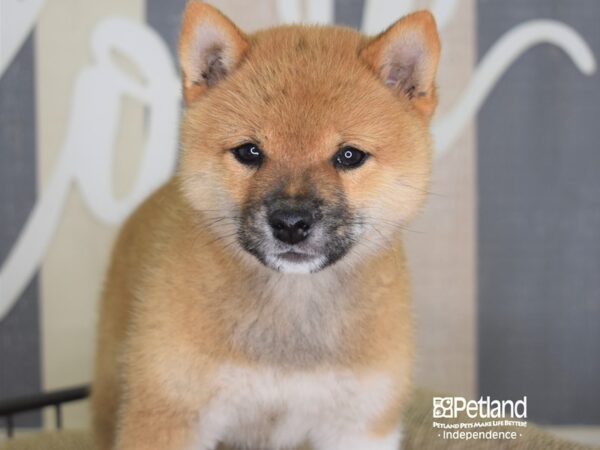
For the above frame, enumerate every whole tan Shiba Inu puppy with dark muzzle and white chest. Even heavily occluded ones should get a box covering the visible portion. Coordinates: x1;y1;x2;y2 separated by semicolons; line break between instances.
93;1;440;450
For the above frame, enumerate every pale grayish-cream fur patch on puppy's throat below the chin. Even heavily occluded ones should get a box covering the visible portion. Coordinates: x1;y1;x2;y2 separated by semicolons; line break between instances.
226;268;354;368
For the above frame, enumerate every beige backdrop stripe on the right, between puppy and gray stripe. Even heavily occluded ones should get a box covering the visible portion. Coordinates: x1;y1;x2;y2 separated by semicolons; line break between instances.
406;0;476;395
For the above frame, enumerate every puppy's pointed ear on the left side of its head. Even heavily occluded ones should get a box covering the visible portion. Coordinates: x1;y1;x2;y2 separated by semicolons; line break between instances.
179;0;248;104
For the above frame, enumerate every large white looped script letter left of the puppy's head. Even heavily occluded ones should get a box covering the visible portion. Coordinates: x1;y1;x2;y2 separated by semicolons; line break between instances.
0;18;180;320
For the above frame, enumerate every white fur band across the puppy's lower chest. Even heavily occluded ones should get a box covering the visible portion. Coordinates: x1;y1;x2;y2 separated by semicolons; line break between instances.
194;366;399;450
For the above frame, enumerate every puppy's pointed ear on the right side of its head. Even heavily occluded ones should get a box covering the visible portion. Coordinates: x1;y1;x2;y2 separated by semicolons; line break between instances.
360;11;440;118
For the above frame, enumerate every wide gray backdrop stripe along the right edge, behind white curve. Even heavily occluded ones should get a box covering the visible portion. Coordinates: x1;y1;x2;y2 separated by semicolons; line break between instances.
477;0;600;424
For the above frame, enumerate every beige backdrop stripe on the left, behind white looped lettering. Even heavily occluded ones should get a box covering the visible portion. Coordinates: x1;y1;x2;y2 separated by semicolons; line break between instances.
35;0;145;427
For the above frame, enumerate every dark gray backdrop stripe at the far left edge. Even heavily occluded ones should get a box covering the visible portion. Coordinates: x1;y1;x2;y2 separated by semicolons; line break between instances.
0;35;41;426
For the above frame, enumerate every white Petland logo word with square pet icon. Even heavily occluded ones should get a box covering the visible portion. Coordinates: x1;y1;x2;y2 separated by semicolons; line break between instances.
433;396;527;419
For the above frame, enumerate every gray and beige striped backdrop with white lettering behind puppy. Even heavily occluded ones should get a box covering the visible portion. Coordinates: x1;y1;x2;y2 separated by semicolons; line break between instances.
0;0;600;425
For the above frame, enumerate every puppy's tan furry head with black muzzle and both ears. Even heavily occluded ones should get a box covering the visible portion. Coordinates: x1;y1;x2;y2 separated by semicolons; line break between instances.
179;1;440;272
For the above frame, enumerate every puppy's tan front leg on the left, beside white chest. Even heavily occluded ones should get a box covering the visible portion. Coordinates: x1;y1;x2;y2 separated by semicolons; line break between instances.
115;329;218;450
